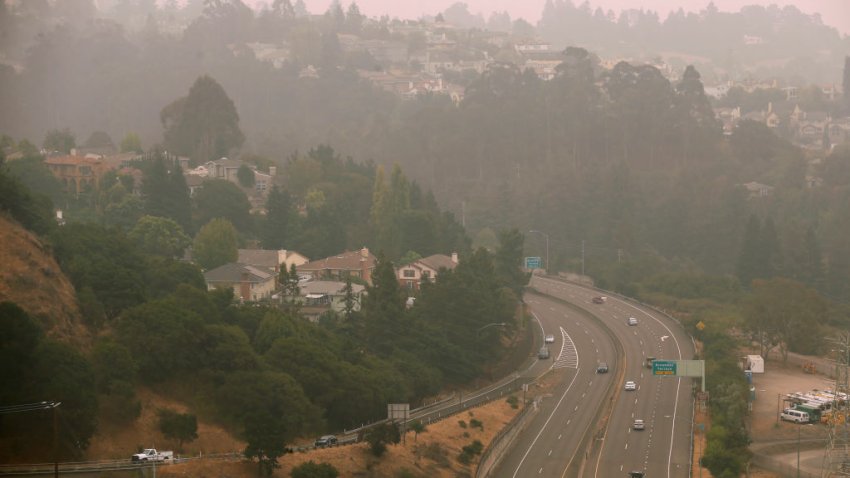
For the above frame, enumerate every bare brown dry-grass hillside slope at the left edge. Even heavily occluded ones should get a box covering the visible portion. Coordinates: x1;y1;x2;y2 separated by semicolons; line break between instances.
0;215;92;349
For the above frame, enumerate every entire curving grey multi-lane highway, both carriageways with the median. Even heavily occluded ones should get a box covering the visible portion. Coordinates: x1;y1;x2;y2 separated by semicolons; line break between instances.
493;276;694;478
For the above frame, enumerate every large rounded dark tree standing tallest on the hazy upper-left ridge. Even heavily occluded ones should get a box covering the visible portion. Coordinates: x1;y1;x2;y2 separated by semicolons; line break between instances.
160;75;245;163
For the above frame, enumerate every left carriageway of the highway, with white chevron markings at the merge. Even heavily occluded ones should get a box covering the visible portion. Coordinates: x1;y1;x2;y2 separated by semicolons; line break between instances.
494;297;615;477
